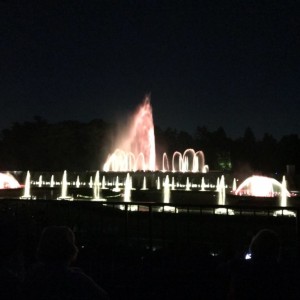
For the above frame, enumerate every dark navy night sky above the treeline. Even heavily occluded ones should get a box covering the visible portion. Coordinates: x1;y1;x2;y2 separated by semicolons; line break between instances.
0;0;300;138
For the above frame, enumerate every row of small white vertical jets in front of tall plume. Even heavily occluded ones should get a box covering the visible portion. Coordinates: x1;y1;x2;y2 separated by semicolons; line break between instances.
20;171;290;214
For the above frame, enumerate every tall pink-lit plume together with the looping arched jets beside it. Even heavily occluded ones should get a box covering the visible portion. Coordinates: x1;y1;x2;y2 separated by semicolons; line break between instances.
103;96;208;173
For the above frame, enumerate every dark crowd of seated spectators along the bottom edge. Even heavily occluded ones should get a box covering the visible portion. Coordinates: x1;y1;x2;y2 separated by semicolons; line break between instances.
0;210;300;300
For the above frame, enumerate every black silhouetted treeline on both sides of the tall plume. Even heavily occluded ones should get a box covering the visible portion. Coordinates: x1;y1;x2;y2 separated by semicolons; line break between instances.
0;117;300;174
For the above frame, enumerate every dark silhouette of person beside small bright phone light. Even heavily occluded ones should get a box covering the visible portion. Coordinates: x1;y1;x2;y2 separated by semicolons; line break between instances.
229;229;289;300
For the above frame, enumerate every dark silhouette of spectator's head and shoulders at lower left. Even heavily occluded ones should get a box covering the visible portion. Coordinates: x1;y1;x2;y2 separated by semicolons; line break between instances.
23;226;108;300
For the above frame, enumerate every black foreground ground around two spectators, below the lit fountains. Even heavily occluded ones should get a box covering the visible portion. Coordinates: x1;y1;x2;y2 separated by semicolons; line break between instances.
0;199;299;299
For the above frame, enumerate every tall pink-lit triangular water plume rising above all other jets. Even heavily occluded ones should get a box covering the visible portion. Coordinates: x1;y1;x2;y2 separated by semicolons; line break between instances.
103;96;155;171
